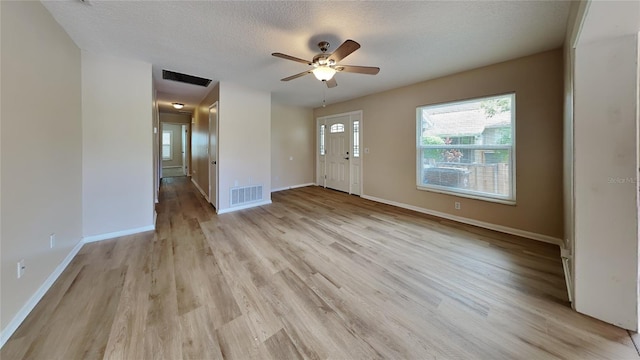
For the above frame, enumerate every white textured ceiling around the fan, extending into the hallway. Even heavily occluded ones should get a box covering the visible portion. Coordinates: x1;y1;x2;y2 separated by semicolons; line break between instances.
43;0;570;111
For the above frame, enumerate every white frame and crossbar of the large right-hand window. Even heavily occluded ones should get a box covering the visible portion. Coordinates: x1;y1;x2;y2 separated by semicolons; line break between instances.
415;93;516;205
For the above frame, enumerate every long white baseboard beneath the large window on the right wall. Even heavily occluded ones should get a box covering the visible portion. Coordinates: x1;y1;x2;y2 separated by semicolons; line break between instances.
362;195;563;247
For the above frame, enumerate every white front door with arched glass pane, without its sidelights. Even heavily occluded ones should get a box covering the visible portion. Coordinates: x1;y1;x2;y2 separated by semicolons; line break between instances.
325;116;351;192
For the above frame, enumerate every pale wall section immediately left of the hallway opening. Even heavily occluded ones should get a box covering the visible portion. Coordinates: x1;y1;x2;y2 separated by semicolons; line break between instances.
82;51;154;237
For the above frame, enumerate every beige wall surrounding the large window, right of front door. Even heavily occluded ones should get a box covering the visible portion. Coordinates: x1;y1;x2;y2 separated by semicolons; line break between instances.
314;49;564;239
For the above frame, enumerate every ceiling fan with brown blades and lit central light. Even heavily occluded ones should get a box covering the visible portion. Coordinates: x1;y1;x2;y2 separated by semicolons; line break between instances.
271;40;380;88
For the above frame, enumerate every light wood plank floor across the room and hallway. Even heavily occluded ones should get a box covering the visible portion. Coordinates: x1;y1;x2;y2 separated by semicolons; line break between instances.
0;178;638;360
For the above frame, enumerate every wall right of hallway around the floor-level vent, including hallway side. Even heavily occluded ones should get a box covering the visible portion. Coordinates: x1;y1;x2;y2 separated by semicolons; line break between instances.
192;83;271;212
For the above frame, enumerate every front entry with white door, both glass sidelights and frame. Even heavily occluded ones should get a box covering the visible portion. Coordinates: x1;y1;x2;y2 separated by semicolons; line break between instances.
316;111;362;195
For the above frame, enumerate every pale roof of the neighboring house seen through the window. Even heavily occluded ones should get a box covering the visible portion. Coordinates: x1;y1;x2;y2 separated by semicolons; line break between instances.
422;109;511;137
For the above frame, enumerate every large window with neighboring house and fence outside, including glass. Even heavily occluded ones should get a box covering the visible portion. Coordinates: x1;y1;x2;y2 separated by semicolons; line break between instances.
416;94;515;204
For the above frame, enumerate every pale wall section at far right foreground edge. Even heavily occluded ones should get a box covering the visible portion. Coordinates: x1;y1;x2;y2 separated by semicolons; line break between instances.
573;2;640;331
